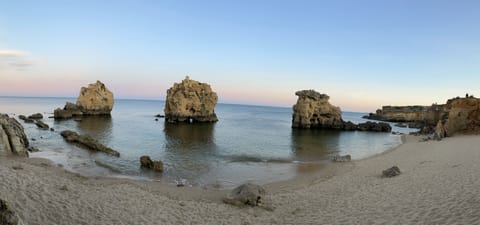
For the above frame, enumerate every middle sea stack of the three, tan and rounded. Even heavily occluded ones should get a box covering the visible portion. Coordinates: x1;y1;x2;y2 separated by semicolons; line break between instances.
165;76;218;123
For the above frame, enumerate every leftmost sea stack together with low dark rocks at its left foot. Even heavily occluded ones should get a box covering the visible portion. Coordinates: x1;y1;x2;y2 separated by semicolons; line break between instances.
54;81;114;119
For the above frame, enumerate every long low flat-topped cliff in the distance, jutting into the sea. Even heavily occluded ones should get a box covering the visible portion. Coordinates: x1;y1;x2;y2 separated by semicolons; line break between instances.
364;104;448;126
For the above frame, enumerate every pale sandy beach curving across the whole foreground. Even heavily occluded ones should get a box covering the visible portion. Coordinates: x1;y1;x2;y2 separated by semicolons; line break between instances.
0;136;480;225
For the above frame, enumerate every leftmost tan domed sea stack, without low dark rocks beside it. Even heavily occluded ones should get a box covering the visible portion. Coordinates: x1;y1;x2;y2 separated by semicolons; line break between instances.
77;81;114;115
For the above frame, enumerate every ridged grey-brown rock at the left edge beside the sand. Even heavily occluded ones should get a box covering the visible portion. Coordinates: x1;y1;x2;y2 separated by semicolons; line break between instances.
0;114;29;156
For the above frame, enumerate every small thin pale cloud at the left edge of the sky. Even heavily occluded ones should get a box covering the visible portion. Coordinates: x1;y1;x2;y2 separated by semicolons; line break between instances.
0;49;33;70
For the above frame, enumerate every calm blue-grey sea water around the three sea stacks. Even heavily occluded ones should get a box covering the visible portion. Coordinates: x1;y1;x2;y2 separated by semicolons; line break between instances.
0;97;411;188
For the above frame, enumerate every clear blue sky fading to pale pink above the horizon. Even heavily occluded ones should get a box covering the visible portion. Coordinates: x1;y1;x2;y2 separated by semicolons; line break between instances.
0;0;480;112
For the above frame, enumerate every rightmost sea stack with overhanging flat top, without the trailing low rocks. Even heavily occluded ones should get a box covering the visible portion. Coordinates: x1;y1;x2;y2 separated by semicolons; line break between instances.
292;90;343;129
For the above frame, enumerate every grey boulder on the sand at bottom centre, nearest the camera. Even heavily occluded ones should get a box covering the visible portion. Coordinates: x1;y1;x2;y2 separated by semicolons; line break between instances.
223;183;265;206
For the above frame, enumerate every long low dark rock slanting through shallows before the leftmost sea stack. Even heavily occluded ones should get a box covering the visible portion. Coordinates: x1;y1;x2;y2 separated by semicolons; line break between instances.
60;130;120;157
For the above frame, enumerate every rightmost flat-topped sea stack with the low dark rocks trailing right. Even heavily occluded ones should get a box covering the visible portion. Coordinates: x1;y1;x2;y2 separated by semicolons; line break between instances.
292;90;392;132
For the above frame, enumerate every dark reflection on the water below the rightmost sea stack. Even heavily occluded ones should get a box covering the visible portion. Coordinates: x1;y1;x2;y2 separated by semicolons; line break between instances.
291;129;341;161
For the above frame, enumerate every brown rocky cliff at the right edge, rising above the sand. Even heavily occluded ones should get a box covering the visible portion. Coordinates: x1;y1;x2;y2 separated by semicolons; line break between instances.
444;97;480;136
